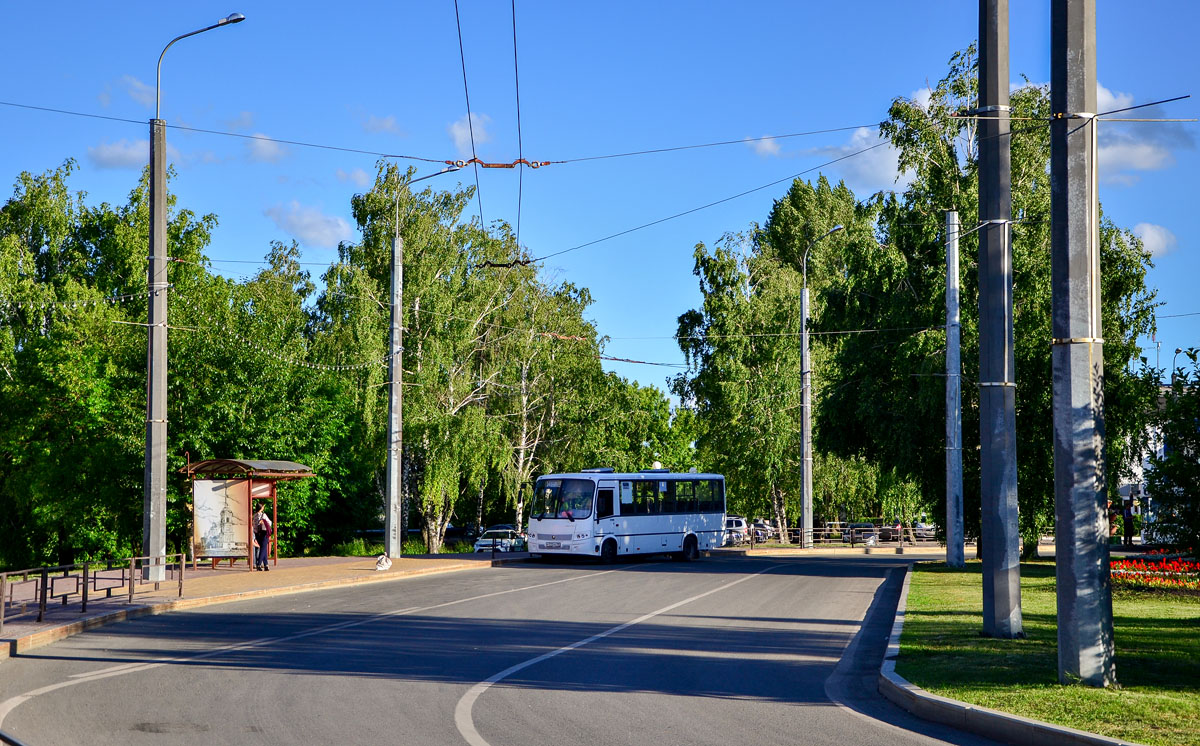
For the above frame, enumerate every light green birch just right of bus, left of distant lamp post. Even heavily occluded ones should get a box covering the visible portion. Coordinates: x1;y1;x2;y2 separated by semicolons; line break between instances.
672;235;803;531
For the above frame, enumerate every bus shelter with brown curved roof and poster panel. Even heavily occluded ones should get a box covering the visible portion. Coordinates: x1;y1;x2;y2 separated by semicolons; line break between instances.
180;458;316;570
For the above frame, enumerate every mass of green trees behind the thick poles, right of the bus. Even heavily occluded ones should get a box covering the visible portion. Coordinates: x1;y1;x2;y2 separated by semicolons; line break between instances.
674;47;1154;551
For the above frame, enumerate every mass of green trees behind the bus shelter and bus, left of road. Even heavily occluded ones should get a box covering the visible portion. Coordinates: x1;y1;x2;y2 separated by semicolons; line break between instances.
0;161;694;566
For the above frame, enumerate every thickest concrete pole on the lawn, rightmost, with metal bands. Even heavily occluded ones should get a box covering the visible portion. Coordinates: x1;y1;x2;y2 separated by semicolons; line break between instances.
1050;0;1116;686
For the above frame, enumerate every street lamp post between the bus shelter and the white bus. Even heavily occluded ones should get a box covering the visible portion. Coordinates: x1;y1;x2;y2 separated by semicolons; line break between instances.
383;166;461;557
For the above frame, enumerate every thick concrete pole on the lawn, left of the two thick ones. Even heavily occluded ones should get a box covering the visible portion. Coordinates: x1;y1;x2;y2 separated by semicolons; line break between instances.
978;0;1024;638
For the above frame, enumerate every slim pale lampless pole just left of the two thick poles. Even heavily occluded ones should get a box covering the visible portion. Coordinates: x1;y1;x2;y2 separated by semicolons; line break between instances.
946;210;966;567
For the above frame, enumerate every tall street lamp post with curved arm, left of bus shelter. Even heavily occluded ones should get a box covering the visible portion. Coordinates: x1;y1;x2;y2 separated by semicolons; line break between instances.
142;13;246;580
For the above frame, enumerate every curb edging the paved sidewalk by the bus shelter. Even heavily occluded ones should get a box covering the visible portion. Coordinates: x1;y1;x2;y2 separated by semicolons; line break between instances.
0;559;487;663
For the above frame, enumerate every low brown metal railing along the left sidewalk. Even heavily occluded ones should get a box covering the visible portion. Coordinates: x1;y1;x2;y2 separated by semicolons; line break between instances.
0;554;185;633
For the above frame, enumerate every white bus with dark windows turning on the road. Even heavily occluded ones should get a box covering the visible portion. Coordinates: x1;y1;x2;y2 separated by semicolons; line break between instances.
529;469;725;562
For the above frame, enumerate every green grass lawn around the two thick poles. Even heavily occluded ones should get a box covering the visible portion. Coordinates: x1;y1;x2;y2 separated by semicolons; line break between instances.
896;562;1200;746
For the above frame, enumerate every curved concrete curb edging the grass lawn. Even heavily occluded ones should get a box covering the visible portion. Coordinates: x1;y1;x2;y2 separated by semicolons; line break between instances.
880;565;1140;746
